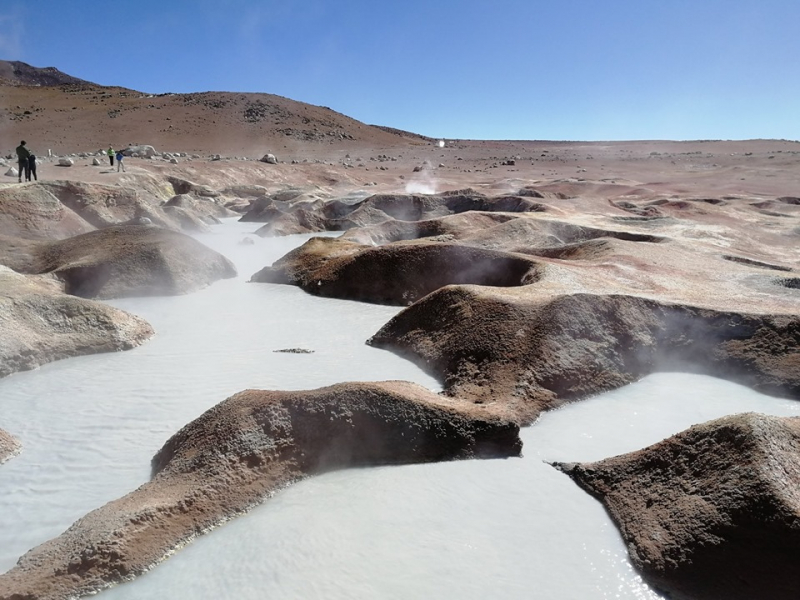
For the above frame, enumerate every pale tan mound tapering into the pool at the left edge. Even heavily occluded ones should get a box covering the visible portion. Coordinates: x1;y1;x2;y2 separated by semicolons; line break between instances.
0;266;153;377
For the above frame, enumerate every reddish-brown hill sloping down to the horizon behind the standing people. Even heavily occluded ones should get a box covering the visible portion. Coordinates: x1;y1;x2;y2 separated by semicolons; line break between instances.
0;62;429;159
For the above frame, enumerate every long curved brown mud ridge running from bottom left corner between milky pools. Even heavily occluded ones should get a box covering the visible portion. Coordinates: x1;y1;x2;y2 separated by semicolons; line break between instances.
0;382;521;600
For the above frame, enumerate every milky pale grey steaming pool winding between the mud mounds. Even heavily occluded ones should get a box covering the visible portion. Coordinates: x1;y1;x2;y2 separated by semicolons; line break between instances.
0;221;800;600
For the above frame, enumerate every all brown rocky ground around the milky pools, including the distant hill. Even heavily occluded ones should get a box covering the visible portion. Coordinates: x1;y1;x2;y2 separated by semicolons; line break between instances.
0;64;800;600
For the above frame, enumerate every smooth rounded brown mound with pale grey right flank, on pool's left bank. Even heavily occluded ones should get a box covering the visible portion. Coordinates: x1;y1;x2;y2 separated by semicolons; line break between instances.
0;225;236;298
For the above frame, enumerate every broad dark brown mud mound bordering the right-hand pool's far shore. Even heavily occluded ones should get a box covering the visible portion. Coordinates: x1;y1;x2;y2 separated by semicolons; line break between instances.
368;286;800;423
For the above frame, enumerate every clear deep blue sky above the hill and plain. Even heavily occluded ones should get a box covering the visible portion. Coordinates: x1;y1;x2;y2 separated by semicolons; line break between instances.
0;0;800;140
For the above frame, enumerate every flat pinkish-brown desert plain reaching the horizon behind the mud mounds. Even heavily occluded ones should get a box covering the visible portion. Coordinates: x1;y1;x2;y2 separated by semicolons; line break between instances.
2;136;800;202
